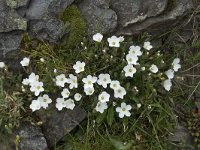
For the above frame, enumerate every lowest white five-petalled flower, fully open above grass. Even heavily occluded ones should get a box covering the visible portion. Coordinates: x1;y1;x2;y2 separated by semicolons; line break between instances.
116;102;132;118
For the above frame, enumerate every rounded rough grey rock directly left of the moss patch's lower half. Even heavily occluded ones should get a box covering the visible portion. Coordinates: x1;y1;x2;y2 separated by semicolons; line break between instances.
29;17;65;42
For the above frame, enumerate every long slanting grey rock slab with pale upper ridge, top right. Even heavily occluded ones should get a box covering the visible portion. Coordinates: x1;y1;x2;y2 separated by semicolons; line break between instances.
118;0;193;35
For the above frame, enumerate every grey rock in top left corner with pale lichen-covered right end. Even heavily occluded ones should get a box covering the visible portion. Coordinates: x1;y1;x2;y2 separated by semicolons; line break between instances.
0;1;27;32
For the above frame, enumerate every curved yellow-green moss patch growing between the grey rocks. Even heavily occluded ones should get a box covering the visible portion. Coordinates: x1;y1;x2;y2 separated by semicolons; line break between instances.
60;5;87;48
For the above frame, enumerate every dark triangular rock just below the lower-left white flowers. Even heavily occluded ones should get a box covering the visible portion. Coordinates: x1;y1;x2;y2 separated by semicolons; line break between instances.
37;106;86;147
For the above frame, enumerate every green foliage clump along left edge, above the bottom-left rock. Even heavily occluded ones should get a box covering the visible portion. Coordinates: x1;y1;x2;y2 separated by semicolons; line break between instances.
0;68;23;137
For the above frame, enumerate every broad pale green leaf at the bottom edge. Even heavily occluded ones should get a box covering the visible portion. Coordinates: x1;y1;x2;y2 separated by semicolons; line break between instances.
109;137;133;150
